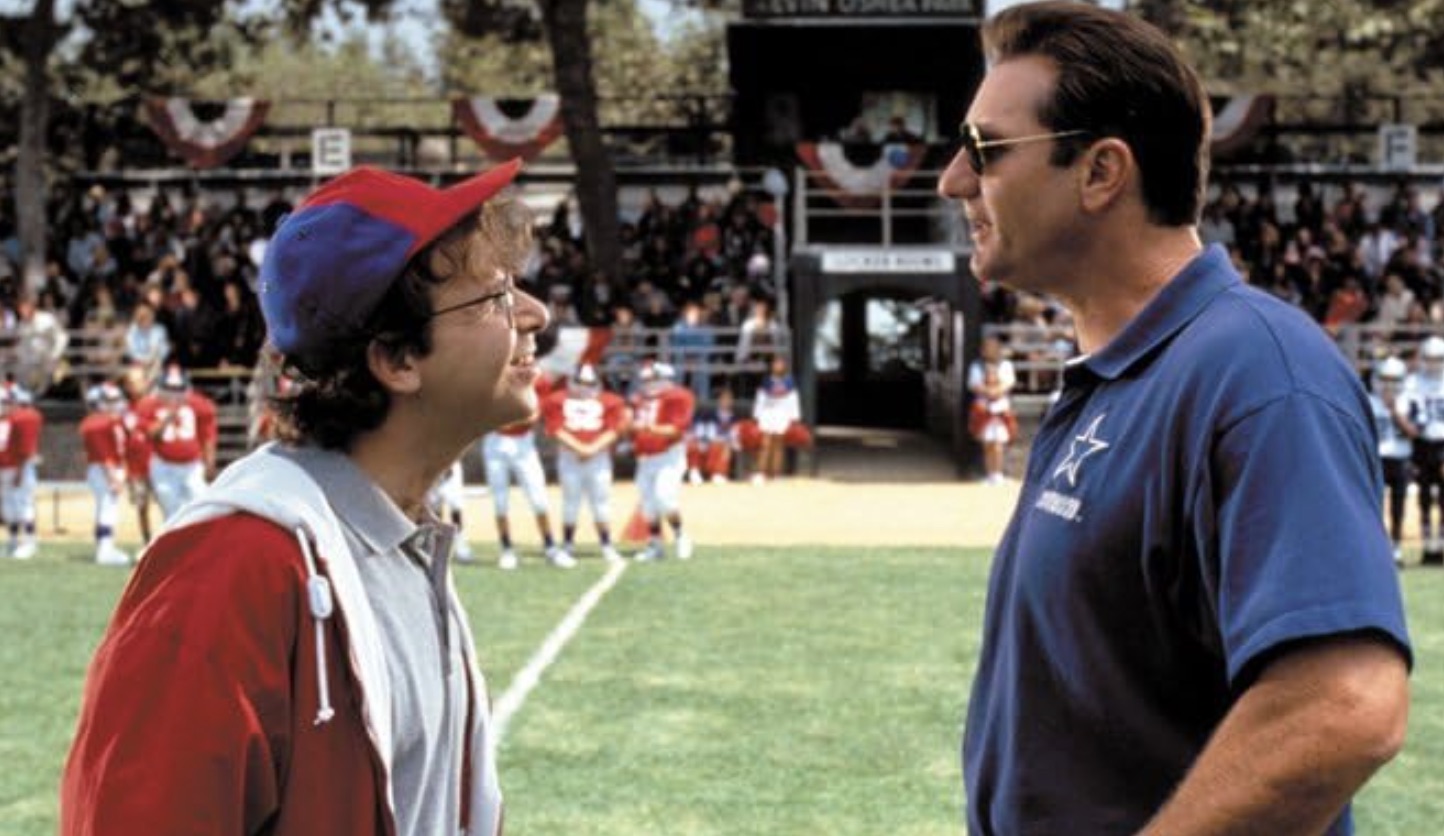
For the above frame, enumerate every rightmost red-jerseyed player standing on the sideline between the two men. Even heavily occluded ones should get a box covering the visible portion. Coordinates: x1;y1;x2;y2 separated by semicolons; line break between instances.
632;362;696;562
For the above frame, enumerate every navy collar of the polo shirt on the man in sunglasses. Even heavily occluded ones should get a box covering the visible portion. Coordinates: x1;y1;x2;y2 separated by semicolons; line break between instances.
1064;244;1243;380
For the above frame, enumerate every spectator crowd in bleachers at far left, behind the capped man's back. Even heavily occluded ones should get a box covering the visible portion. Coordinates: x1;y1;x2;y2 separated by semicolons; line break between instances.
0;178;272;391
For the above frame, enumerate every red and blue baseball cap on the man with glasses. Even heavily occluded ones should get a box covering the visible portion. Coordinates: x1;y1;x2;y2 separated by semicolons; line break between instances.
258;159;521;369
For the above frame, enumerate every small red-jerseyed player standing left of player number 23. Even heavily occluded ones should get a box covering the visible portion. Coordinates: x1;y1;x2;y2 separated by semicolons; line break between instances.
79;383;130;566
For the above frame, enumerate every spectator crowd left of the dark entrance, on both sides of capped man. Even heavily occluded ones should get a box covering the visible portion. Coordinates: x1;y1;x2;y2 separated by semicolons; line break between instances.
0;176;783;401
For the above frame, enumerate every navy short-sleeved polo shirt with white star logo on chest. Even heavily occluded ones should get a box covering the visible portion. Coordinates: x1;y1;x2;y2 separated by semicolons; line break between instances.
963;245;1409;836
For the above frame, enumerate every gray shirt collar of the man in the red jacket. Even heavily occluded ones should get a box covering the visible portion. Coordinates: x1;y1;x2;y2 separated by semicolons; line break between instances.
275;448;417;554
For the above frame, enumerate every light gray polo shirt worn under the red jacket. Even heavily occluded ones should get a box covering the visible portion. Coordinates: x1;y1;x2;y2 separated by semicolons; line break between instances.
274;446;468;836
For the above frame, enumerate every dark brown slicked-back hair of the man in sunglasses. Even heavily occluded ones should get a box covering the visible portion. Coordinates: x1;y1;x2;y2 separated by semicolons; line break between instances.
982;0;1212;227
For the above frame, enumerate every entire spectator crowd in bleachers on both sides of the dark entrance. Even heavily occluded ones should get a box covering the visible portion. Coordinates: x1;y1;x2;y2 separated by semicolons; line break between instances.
8;171;1444;399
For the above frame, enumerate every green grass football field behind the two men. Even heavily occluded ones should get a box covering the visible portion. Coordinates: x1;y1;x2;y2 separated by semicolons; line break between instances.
0;547;1444;836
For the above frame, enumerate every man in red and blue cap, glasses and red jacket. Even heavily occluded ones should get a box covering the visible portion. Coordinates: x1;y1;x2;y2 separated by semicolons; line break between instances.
61;162;546;836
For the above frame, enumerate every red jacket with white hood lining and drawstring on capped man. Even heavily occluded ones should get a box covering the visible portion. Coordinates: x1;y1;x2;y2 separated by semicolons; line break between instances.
59;448;501;836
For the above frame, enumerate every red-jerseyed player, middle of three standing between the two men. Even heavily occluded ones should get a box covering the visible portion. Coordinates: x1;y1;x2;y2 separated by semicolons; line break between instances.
542;365;627;563
